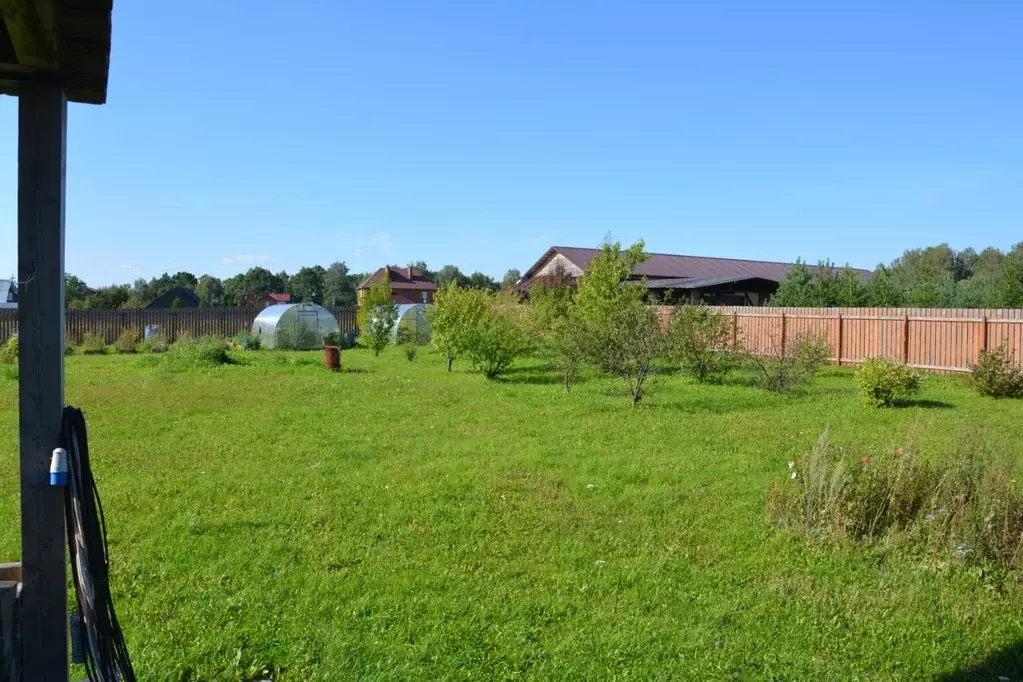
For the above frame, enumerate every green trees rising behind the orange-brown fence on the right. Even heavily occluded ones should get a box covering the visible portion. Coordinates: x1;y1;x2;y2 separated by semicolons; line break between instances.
770;241;1023;308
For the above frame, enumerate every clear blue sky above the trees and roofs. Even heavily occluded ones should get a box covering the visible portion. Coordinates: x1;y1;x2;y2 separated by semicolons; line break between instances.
0;0;1023;285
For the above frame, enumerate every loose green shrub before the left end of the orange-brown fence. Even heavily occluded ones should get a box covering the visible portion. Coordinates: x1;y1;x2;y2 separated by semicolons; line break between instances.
664;304;736;383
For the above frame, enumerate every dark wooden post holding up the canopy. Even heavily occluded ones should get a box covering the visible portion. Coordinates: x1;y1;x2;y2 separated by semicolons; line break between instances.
17;83;69;682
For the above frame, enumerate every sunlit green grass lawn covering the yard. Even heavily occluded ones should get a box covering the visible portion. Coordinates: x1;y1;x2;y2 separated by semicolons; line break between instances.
0;349;1023;680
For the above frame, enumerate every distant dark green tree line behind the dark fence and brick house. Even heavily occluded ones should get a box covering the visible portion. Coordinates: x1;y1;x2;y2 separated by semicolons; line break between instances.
64;261;519;308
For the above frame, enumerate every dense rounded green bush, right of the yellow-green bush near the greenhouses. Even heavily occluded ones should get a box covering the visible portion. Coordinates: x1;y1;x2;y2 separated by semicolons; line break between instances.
465;291;530;379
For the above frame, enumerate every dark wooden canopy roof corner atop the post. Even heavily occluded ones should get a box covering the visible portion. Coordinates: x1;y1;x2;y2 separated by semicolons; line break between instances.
0;0;114;104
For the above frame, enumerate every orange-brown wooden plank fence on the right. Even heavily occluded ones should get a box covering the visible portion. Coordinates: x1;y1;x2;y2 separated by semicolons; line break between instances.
661;306;1023;372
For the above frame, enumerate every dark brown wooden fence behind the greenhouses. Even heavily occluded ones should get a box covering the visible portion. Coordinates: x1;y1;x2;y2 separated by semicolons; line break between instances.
0;306;357;344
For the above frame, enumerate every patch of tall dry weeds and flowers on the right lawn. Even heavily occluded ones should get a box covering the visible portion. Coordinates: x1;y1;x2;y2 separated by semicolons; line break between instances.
767;435;1023;571
